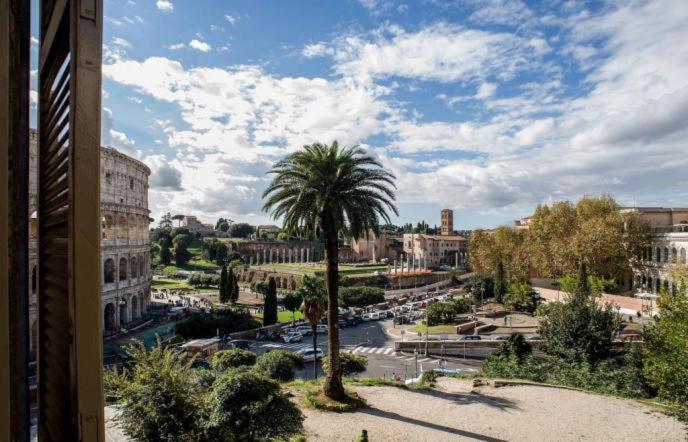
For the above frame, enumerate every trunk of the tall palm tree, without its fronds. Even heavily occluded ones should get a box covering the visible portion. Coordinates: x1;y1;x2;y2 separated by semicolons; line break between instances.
323;230;344;400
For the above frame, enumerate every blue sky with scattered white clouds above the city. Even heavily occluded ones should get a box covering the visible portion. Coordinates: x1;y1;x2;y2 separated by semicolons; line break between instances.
29;0;688;229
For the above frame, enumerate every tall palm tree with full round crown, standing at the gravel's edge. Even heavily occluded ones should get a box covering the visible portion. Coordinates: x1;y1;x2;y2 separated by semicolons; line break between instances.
263;141;398;399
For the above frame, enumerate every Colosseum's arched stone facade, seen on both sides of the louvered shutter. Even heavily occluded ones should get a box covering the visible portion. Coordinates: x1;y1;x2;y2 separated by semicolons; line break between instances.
29;131;152;351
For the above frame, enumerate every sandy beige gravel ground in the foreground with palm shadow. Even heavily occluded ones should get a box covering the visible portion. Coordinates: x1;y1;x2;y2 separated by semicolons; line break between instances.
304;379;688;441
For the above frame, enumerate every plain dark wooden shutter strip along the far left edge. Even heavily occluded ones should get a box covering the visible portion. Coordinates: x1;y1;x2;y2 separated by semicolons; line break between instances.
0;0;30;441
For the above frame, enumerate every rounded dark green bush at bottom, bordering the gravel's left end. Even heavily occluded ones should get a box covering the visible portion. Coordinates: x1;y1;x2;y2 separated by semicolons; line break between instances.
208;371;303;440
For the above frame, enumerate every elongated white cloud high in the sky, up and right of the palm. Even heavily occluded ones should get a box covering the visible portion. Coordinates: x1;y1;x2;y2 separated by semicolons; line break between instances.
326;23;544;82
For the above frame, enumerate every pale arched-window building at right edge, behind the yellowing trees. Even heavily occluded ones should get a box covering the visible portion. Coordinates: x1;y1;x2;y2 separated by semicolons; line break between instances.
622;207;688;294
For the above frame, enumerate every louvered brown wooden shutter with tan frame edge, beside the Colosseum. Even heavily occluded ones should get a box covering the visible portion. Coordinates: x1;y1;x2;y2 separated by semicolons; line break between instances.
38;0;104;441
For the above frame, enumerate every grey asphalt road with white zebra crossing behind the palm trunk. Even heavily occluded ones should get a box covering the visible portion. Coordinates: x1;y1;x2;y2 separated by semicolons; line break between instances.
251;320;480;379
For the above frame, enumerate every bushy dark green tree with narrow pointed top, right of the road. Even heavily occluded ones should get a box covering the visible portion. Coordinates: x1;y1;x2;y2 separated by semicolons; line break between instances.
540;264;621;364
